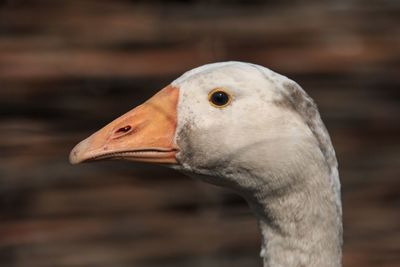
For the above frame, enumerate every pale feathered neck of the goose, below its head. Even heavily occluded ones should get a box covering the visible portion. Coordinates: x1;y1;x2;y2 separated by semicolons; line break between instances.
242;165;342;267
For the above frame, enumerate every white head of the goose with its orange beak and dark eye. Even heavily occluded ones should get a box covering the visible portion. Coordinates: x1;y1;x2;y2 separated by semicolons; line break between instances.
70;62;332;192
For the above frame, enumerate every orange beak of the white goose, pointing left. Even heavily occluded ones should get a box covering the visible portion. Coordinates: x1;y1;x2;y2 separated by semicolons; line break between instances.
69;85;179;164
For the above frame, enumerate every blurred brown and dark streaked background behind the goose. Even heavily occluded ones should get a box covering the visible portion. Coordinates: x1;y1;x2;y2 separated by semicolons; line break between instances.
0;0;400;267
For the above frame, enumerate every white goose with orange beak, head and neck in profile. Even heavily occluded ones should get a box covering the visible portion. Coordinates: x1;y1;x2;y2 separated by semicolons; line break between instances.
70;61;342;267
